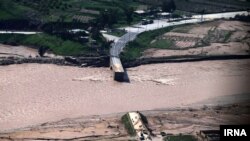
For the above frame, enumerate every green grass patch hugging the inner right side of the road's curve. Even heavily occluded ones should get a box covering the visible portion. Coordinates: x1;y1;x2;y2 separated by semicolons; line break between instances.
121;27;173;61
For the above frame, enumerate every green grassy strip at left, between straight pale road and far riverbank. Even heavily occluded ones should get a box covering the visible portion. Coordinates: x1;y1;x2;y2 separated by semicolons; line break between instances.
0;34;93;55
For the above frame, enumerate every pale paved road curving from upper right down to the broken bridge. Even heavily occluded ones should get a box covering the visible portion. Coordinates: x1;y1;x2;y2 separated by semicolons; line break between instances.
110;11;249;65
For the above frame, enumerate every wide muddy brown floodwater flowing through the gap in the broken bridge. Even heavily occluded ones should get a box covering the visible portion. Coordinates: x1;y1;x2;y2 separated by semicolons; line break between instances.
0;60;250;131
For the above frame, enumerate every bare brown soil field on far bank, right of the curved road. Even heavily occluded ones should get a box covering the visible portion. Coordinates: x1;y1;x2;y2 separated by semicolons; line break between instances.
143;20;250;58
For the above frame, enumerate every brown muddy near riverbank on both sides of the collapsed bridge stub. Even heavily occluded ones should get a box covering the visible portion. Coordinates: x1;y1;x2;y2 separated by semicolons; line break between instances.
0;102;250;141
